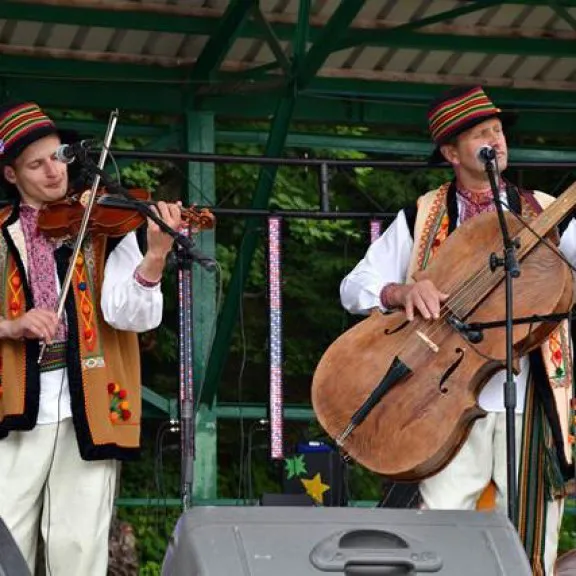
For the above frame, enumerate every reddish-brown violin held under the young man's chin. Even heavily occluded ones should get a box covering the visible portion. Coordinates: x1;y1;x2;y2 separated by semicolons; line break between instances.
38;188;214;238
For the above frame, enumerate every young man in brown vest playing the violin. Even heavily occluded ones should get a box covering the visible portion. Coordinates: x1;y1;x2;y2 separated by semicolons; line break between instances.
0;102;180;576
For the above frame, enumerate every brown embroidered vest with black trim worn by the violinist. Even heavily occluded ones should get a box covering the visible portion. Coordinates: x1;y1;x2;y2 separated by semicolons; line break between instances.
0;207;141;460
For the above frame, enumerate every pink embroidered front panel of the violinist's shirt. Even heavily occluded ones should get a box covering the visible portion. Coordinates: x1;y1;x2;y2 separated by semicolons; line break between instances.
20;204;66;341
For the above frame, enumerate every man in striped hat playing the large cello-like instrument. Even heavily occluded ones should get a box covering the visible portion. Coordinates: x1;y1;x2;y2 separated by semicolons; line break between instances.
340;86;576;576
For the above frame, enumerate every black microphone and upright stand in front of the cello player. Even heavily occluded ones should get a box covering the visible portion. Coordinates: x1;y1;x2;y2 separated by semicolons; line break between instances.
483;149;520;526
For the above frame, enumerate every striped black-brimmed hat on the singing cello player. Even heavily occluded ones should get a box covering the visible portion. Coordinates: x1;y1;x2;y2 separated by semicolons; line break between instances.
428;86;515;164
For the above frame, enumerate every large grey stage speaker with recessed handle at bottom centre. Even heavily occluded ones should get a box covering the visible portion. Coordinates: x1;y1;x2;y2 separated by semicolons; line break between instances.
162;507;532;576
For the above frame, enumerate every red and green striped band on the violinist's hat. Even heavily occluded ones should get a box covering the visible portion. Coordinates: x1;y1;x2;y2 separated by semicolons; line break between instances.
0;102;56;154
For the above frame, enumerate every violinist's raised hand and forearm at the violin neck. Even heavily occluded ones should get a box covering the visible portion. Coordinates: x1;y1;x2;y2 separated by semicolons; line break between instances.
138;202;182;281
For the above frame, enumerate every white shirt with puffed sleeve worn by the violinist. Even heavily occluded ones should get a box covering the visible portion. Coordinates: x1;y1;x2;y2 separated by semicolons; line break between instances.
37;232;163;424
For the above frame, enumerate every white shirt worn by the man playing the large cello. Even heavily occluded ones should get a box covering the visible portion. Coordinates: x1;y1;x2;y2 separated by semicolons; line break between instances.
340;196;576;414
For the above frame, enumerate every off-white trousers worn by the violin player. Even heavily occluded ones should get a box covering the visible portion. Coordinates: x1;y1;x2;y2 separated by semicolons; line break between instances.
0;418;116;576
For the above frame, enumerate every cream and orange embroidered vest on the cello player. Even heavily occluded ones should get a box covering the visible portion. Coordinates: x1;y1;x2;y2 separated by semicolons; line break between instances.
407;183;574;462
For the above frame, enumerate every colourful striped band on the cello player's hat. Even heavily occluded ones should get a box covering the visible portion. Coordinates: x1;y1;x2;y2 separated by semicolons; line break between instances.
428;87;502;143
